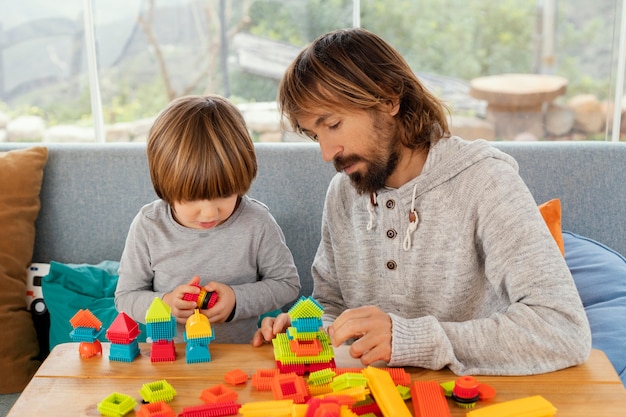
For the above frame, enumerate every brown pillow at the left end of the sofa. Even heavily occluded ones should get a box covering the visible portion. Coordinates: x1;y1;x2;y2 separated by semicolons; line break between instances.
0;146;48;394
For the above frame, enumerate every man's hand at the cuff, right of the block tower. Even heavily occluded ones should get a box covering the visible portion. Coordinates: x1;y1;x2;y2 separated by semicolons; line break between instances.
328;306;391;366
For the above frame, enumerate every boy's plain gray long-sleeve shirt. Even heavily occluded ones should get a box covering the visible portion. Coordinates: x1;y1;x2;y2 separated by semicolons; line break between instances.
115;196;300;343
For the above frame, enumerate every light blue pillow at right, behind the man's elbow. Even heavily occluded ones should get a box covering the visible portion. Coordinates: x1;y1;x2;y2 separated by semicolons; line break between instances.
563;231;626;386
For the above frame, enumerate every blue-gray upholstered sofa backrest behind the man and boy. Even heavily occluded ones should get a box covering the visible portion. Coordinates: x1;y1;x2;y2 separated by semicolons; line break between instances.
0;142;626;415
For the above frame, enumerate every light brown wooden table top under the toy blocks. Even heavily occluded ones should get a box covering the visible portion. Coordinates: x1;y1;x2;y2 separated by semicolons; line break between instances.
8;343;626;417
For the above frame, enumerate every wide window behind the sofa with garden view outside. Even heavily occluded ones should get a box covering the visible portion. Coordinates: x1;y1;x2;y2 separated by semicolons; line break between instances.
0;0;626;142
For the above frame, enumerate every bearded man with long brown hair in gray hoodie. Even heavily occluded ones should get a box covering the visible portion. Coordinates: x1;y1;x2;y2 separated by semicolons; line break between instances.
253;29;591;375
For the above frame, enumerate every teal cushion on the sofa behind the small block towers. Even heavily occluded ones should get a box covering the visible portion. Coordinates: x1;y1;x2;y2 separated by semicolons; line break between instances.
42;261;146;350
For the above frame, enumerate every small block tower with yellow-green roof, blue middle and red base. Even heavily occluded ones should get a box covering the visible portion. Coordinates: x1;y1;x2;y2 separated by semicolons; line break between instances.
146;297;176;362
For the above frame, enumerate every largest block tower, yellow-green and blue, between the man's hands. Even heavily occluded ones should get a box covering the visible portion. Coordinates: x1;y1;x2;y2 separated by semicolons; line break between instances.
272;296;335;375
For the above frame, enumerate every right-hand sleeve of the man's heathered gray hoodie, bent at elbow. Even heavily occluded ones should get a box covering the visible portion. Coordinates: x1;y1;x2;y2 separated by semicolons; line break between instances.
389;158;591;375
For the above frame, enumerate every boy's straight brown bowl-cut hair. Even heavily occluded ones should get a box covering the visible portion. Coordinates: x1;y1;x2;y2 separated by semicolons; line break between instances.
146;95;257;204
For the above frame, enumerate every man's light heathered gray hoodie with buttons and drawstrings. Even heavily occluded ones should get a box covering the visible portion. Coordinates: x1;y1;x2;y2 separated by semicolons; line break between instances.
312;137;591;375
